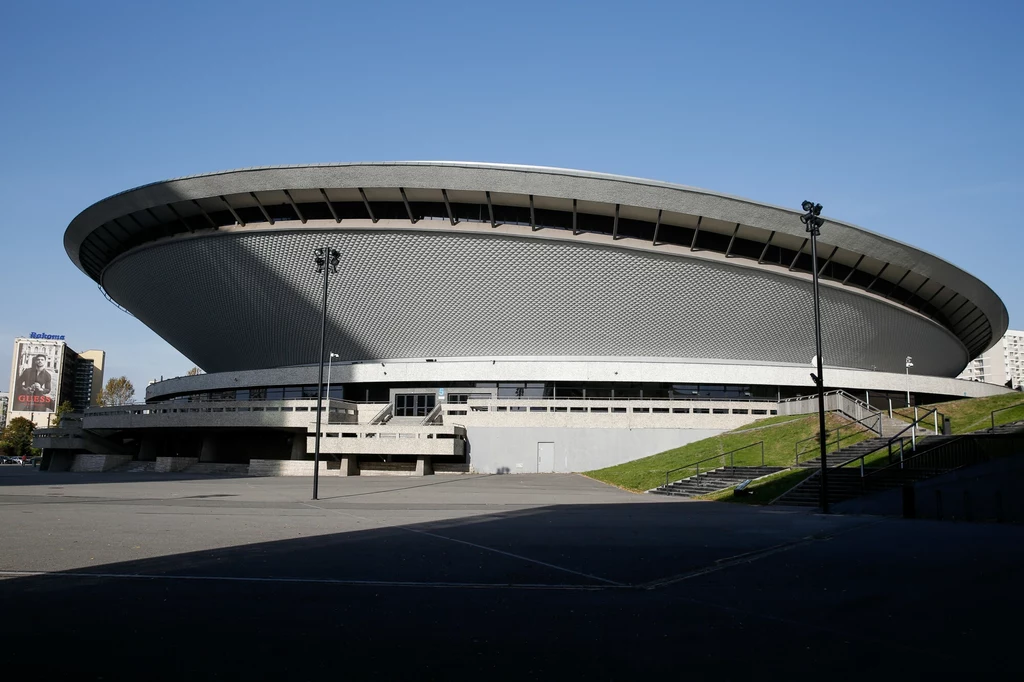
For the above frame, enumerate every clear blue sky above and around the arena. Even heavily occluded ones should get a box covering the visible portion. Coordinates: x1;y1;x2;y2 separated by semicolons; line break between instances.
0;0;1024;397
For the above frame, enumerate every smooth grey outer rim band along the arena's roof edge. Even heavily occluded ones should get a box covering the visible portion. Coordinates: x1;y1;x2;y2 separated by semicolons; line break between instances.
65;161;1009;347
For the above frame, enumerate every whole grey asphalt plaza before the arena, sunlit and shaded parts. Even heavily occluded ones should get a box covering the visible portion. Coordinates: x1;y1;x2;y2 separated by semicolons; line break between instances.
0;467;1024;680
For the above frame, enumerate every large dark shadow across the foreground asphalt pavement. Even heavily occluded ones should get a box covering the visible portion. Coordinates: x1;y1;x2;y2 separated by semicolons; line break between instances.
0;503;1024;680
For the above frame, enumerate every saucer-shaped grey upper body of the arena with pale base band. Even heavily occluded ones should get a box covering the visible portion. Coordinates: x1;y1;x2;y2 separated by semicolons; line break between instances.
65;162;1008;397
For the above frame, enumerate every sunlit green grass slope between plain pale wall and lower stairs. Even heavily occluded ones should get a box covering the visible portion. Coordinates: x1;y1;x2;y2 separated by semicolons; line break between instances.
585;414;872;493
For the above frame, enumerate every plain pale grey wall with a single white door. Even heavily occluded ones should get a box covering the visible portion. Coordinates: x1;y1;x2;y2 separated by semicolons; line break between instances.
466;426;726;473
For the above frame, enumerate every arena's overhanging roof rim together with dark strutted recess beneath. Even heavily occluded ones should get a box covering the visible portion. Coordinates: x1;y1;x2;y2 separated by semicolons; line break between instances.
65;162;1009;357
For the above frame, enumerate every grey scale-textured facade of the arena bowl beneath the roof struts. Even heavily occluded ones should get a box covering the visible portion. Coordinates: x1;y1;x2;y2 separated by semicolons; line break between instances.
102;229;969;376
